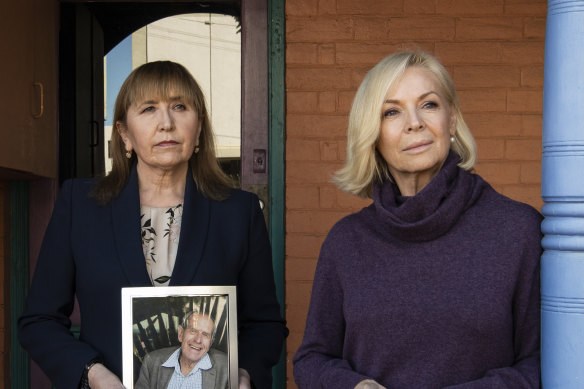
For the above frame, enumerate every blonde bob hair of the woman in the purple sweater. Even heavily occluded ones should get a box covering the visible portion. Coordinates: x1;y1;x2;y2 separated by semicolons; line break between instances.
333;51;476;198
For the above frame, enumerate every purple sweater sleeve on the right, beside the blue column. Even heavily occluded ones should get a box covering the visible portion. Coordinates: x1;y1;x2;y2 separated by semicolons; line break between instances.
447;211;542;389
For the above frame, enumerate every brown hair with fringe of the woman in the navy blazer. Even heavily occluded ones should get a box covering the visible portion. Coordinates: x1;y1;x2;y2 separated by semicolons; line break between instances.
92;61;233;204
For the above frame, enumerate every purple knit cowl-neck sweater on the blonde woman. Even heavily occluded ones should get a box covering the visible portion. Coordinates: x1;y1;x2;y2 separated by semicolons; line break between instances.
294;153;541;389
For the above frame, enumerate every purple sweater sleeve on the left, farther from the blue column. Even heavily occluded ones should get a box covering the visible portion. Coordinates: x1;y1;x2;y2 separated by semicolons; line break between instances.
293;229;370;389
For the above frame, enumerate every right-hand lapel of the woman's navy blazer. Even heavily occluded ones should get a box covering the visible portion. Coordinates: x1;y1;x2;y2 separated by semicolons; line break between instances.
170;169;211;285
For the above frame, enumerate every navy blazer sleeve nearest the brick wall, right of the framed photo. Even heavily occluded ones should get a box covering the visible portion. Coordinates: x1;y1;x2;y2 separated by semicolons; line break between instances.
237;196;288;389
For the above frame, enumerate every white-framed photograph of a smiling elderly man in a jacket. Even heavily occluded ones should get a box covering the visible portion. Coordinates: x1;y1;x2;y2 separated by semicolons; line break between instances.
122;286;238;389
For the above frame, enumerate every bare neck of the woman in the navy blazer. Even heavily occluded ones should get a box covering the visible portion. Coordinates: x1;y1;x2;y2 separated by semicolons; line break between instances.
136;164;188;207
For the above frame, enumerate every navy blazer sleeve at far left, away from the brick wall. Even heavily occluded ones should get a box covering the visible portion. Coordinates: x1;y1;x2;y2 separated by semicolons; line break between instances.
18;181;99;388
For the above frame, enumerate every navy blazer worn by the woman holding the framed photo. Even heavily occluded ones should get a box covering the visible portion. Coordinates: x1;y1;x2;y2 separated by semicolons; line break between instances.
18;168;288;389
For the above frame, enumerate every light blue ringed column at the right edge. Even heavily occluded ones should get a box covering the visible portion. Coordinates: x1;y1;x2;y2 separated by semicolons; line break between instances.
541;0;584;389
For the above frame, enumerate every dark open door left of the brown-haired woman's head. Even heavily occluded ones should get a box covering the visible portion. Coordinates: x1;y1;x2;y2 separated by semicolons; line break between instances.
59;3;105;182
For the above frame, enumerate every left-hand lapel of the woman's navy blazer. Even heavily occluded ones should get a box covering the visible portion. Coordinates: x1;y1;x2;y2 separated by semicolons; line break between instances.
111;164;152;286
